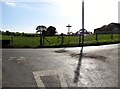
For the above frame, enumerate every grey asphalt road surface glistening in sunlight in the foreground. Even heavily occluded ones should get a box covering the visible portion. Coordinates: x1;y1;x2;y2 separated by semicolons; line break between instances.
2;44;118;87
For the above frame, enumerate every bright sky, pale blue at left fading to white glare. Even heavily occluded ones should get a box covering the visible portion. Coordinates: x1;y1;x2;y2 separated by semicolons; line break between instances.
0;0;120;33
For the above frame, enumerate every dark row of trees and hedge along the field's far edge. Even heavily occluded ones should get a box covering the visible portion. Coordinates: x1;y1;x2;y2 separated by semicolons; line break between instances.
1;25;92;37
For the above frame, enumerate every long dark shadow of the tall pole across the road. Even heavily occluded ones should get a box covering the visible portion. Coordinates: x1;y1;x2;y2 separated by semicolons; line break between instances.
74;46;83;83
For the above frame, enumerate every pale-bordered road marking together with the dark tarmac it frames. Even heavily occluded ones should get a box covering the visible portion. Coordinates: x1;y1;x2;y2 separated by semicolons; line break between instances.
33;70;68;89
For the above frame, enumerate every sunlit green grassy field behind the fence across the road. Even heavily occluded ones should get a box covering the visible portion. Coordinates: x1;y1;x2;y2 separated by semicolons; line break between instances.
0;34;120;48
